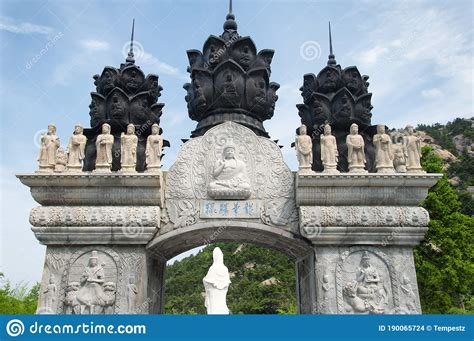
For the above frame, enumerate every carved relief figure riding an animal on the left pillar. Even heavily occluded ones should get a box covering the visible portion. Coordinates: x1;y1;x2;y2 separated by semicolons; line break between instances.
76;251;105;315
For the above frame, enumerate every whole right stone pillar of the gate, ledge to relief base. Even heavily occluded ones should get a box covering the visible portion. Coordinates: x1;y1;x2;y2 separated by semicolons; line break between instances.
296;173;440;314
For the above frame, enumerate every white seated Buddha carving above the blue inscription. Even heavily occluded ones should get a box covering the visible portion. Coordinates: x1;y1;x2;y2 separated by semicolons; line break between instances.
207;144;252;199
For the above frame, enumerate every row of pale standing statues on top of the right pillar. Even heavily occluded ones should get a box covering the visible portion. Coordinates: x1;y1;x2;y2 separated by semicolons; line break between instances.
295;123;424;174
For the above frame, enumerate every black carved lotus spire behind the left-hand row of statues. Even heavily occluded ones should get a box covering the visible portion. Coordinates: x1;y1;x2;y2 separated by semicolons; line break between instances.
84;19;168;171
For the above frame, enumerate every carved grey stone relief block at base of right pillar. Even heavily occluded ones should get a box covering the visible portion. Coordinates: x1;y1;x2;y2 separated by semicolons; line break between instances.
316;246;421;314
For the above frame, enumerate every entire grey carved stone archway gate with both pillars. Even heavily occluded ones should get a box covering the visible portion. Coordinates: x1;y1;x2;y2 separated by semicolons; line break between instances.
18;122;439;314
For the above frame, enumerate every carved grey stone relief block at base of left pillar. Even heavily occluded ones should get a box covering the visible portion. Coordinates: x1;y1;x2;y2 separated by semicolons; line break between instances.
36;246;149;315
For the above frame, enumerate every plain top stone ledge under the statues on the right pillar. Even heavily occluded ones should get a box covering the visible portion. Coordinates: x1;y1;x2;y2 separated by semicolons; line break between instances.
296;173;442;206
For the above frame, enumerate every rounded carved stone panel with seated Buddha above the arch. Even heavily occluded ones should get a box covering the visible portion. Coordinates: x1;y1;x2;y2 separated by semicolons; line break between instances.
160;122;298;233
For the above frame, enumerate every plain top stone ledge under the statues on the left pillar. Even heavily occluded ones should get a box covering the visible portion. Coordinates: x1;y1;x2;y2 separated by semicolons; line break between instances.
17;173;164;207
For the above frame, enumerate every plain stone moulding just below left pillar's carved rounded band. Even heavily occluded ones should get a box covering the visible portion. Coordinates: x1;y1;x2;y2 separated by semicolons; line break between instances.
31;226;158;245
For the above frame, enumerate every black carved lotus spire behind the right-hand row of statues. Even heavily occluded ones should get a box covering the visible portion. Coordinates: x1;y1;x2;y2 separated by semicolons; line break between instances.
296;23;375;171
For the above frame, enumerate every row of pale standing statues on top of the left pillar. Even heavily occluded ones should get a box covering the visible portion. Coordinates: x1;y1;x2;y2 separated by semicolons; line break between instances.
37;123;163;173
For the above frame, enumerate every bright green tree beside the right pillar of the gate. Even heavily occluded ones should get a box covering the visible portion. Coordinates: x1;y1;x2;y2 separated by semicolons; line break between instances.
415;147;474;313
